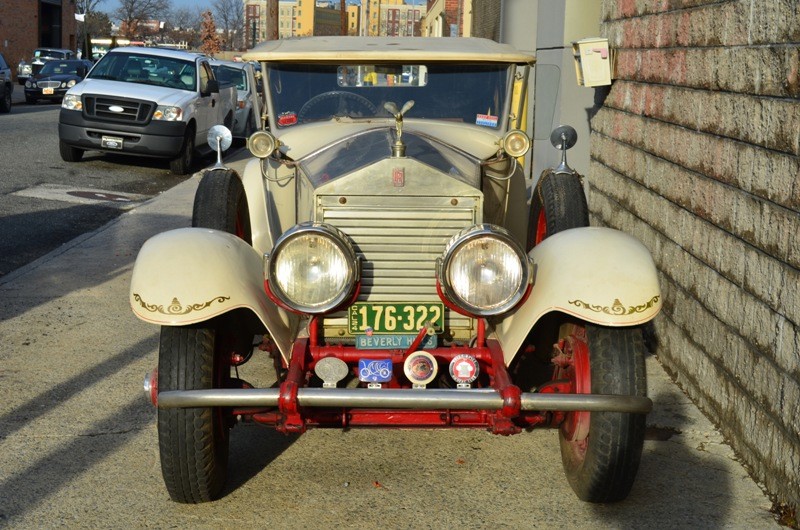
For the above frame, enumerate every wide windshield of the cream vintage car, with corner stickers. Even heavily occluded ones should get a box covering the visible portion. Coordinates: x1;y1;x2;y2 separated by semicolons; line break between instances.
267;63;512;130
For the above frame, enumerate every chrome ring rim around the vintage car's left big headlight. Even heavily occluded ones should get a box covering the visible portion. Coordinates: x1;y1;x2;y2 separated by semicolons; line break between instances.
264;221;360;315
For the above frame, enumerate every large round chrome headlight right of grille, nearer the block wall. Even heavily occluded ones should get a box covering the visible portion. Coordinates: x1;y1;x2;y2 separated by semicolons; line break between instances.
436;224;530;316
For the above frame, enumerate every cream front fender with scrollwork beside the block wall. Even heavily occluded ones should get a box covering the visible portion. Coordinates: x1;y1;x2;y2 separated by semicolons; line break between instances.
495;227;661;364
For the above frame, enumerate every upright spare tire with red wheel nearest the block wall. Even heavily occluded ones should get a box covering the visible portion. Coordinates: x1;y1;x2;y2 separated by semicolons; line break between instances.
528;169;589;250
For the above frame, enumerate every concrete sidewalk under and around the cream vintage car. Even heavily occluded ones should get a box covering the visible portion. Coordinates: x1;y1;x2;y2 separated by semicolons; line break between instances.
0;163;777;528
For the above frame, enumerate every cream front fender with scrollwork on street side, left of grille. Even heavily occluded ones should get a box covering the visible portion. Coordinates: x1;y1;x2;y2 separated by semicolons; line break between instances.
130;228;292;359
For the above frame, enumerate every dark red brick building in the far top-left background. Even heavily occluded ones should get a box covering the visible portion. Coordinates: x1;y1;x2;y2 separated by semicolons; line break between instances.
0;0;76;79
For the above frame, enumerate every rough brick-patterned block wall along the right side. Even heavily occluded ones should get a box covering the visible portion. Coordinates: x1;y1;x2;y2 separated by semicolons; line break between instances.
589;0;800;509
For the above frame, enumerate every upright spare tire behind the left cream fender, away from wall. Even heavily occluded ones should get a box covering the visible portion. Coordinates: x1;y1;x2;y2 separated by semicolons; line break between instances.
192;169;253;244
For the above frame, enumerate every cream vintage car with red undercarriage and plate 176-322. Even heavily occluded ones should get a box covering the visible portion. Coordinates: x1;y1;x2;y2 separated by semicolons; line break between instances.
130;37;661;503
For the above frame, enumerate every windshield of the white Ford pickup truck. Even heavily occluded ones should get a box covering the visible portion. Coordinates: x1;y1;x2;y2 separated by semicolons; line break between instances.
88;53;196;90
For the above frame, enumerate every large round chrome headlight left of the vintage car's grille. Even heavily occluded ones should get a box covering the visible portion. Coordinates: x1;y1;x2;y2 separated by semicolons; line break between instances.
264;223;358;314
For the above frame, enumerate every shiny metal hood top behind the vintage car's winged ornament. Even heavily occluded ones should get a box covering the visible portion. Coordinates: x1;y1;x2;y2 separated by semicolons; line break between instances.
300;127;481;187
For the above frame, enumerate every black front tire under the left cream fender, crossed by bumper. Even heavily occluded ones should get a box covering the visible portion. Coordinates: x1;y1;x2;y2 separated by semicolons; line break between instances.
158;326;233;503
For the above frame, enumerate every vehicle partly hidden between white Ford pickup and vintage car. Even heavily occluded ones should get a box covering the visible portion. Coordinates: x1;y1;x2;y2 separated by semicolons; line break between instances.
211;61;263;138
